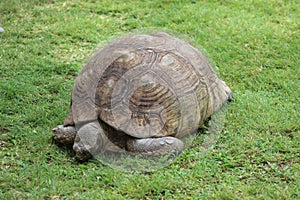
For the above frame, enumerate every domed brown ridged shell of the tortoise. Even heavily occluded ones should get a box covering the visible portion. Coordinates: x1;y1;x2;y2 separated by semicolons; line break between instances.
65;33;231;138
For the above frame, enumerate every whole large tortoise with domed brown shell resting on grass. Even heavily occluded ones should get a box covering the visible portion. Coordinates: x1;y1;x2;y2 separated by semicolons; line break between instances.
53;32;232;161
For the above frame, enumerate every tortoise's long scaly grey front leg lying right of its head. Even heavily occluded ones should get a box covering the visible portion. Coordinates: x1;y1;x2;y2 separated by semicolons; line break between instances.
127;137;184;156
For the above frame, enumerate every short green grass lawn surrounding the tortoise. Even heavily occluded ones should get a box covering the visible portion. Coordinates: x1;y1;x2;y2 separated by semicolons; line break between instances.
0;0;300;199
